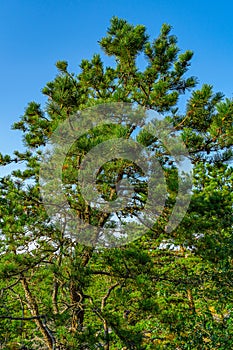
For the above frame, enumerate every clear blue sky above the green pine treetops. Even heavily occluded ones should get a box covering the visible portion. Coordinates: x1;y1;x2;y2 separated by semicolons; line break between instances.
0;0;233;159
